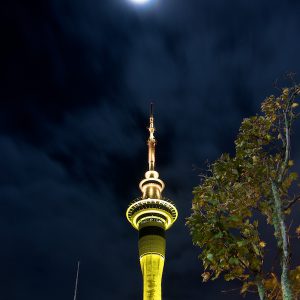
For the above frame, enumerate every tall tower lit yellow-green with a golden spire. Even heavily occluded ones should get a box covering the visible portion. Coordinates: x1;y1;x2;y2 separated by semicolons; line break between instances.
126;104;178;300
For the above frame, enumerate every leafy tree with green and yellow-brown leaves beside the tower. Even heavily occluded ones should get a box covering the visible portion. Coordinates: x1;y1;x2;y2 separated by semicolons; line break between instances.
187;83;300;300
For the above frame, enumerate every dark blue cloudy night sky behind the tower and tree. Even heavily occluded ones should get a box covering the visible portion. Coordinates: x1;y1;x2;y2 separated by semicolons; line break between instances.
0;0;300;300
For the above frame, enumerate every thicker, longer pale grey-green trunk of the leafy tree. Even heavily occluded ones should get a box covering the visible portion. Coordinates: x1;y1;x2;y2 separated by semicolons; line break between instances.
272;182;293;300
